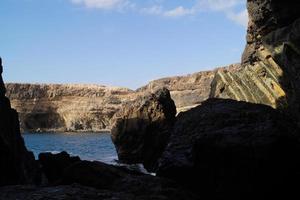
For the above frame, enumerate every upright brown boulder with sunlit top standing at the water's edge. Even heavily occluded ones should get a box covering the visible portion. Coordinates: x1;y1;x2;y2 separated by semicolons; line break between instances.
111;88;176;171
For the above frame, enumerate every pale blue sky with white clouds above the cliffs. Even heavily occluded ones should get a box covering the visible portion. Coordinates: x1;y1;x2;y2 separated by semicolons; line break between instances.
0;0;247;89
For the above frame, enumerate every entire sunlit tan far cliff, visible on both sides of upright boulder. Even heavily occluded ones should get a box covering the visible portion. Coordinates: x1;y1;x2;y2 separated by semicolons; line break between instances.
6;64;234;132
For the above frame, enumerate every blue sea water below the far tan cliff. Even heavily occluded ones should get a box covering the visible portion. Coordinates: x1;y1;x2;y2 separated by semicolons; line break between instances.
23;133;117;164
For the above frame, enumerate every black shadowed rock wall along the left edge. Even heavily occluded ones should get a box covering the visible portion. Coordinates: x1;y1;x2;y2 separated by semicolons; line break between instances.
0;58;39;186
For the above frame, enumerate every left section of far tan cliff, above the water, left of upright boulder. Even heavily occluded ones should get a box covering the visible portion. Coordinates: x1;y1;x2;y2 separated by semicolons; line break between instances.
6;84;135;132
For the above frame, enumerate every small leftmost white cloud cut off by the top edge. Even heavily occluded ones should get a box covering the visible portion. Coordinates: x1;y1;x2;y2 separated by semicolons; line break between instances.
71;0;129;10
